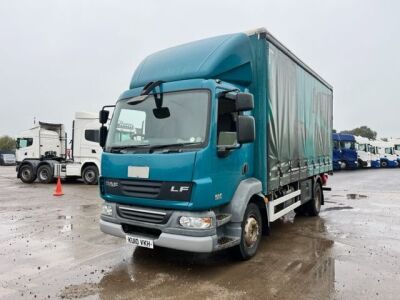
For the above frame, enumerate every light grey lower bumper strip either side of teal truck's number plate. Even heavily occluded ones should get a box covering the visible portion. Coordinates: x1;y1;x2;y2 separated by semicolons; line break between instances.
100;220;217;253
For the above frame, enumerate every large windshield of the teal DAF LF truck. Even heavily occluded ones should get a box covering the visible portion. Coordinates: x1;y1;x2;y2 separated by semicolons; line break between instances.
106;90;209;151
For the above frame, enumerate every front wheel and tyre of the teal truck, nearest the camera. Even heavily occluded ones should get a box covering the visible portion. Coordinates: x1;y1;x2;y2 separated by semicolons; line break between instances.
237;203;262;260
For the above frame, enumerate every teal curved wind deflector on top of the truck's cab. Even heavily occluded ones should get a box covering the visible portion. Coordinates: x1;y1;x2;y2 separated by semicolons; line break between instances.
130;33;252;89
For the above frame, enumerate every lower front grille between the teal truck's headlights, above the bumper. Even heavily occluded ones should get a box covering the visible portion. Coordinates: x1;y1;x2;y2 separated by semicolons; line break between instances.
117;205;169;224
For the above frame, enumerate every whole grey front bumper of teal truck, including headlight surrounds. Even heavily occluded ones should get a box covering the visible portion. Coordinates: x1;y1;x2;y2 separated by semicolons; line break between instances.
100;202;241;253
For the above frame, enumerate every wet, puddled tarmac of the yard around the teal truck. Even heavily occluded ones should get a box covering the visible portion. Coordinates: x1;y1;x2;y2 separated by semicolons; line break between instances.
0;167;400;300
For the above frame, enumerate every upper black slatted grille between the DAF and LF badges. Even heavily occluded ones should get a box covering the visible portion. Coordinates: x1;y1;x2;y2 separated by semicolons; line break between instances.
119;180;162;198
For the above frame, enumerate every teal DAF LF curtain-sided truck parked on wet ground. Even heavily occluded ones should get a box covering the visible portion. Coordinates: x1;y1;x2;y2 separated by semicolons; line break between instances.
99;29;333;259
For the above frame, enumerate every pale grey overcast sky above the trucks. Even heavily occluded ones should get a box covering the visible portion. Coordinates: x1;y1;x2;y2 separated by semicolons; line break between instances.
0;0;400;137
